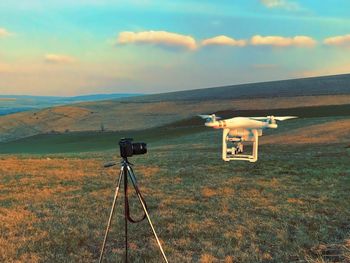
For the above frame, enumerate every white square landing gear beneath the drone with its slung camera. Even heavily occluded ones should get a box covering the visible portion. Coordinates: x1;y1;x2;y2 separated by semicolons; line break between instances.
222;129;259;162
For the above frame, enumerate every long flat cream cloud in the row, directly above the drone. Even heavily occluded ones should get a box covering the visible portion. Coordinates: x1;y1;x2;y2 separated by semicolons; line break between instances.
250;35;316;47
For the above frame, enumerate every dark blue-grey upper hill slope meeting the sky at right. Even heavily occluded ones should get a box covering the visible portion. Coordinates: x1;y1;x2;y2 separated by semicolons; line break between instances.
127;74;350;102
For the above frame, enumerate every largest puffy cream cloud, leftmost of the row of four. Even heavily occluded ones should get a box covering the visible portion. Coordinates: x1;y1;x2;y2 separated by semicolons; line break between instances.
117;31;197;50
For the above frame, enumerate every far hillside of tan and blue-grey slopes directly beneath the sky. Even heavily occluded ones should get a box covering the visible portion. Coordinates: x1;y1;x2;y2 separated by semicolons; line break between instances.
0;75;350;141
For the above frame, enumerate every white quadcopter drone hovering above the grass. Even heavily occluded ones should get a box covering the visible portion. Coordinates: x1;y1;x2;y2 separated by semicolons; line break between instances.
199;114;297;162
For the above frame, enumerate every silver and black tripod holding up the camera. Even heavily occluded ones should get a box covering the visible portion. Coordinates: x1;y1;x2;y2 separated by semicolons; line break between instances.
99;157;168;263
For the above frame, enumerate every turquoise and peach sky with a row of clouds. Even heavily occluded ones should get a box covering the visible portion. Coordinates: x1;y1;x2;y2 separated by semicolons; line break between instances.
0;0;350;96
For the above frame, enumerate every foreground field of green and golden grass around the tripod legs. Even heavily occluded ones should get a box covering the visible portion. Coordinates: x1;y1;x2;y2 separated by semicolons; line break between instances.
0;125;350;262
